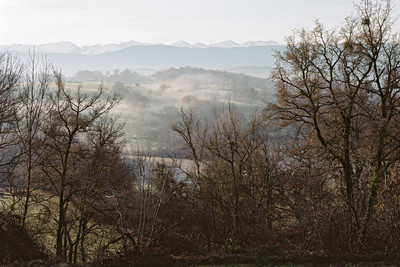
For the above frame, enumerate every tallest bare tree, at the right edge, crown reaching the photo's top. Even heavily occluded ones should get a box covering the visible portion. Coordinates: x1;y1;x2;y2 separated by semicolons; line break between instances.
266;0;400;250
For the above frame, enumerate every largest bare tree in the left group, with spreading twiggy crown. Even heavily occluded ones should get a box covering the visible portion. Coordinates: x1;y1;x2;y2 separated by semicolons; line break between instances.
42;72;118;261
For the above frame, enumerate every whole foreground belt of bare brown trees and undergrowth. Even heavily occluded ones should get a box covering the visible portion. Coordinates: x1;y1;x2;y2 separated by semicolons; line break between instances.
0;0;400;264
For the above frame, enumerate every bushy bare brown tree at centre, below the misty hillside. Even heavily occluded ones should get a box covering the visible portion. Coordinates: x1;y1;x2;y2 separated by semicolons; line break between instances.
173;102;276;251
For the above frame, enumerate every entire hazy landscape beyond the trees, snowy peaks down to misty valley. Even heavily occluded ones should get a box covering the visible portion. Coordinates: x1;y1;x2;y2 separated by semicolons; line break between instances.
0;41;278;156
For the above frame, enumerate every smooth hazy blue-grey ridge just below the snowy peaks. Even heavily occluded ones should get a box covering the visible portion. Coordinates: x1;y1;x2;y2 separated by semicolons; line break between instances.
0;43;285;75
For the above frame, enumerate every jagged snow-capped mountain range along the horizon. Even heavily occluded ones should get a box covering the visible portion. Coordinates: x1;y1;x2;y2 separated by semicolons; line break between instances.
0;40;280;55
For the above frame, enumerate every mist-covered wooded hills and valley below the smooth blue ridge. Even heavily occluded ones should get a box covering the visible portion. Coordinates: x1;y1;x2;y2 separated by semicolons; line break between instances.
66;67;274;157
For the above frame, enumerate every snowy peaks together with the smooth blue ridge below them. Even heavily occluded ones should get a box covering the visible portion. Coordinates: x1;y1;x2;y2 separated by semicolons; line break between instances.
0;41;284;77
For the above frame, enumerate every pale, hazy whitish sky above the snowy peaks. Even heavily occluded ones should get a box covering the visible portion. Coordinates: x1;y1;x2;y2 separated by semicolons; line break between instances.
0;0;378;45
